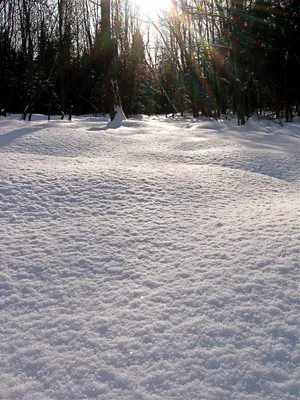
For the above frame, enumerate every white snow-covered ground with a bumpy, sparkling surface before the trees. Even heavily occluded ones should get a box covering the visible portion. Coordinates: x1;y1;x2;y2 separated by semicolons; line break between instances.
0;116;300;400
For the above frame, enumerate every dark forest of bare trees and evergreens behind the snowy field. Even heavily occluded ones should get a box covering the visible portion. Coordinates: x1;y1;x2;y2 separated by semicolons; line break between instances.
0;0;300;125
